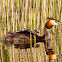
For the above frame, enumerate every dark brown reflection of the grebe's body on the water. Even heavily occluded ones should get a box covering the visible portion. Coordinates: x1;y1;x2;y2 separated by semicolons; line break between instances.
5;42;39;49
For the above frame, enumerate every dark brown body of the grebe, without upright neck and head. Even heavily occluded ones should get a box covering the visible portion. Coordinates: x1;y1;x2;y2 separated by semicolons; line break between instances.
5;30;45;48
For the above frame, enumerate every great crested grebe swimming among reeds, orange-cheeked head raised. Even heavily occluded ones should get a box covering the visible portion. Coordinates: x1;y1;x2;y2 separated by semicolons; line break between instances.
5;18;62;49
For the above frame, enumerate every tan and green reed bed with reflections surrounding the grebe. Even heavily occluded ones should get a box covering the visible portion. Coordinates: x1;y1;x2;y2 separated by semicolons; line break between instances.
0;0;62;62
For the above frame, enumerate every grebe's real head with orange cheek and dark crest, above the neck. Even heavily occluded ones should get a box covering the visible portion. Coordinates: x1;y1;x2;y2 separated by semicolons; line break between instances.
45;18;62;29
